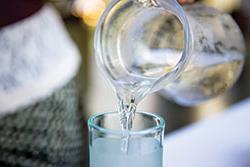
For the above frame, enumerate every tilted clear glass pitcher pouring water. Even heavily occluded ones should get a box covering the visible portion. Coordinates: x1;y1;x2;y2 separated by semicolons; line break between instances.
95;0;245;105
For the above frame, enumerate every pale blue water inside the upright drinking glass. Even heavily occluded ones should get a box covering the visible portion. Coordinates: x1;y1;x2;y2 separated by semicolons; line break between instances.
90;138;163;167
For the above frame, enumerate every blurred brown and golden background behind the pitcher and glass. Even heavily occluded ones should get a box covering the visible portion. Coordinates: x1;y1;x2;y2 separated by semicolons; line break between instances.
48;0;250;134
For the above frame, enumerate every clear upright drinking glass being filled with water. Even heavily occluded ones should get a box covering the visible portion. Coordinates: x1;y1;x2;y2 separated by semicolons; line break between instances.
88;112;165;167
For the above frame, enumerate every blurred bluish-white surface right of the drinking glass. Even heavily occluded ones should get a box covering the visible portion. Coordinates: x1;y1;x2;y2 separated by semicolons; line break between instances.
164;99;250;167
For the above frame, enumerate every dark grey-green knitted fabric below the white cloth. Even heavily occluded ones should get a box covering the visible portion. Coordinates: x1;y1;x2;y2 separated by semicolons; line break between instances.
0;81;86;167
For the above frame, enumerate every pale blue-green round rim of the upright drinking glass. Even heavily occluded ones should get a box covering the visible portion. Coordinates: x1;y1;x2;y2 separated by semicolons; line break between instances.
88;111;165;136
